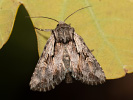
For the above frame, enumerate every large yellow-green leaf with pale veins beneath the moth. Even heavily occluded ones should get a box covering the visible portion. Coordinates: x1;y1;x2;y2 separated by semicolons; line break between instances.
0;0;133;79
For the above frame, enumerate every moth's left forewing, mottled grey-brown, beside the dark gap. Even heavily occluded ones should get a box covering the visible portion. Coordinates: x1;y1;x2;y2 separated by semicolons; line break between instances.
30;34;66;91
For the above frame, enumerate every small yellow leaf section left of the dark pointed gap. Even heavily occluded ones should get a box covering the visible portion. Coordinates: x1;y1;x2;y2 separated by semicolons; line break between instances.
0;0;20;48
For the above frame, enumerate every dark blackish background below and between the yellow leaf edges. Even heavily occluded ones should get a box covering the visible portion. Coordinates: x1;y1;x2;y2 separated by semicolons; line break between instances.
0;5;133;100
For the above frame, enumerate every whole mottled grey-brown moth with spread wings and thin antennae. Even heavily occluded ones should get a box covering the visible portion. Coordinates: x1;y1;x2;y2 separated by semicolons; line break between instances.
30;6;105;91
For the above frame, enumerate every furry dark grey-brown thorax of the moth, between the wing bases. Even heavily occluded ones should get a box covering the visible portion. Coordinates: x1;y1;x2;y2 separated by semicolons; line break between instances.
54;21;74;43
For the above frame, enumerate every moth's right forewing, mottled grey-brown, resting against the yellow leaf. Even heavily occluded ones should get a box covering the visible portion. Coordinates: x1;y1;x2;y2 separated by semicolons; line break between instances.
71;33;105;85
